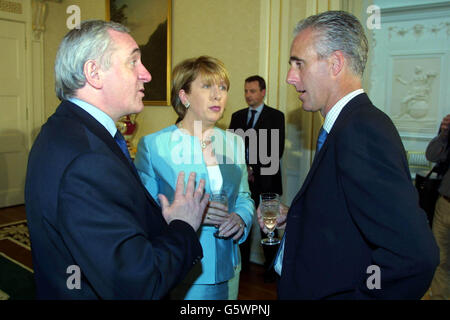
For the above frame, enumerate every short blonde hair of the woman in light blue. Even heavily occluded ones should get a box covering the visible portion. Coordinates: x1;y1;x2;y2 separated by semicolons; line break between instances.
171;56;230;121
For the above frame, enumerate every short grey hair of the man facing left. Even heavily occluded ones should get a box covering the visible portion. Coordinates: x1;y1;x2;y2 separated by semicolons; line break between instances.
294;11;369;77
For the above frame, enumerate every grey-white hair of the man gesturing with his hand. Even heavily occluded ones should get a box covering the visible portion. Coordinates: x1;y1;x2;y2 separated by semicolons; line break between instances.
55;20;129;100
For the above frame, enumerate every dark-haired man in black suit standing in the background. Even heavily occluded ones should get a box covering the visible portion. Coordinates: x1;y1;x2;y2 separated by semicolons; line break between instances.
229;75;285;281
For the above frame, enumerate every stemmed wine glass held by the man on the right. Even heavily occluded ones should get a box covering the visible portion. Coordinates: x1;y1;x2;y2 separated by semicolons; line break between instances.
260;192;280;246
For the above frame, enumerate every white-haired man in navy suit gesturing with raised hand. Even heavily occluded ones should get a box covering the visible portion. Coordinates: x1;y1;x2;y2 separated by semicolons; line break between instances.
25;21;208;299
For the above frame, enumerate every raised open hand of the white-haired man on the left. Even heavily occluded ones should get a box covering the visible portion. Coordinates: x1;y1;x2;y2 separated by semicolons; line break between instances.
158;172;209;231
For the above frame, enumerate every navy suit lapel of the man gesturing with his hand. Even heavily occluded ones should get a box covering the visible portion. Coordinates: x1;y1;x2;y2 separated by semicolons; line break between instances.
60;101;158;206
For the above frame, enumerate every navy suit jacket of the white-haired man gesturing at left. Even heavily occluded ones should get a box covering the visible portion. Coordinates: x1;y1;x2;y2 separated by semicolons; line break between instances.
25;101;202;299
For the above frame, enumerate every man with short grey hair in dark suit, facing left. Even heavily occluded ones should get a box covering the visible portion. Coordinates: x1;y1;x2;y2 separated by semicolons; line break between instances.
260;11;439;299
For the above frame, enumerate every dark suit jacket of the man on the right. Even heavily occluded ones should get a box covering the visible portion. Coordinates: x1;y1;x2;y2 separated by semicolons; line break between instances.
278;94;439;299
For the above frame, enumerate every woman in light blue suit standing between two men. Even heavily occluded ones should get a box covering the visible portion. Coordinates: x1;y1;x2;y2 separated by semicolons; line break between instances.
135;56;254;300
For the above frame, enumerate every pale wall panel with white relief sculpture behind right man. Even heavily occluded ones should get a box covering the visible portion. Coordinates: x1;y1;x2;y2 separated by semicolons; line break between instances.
368;0;450;173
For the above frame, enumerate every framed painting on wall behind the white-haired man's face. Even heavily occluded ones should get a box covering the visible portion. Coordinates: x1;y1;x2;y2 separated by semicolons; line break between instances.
106;0;172;106
